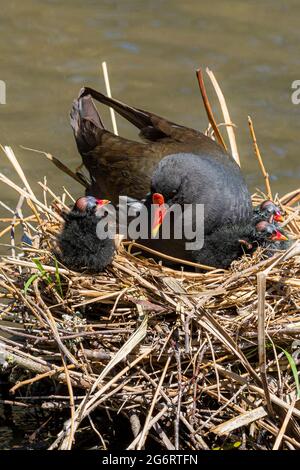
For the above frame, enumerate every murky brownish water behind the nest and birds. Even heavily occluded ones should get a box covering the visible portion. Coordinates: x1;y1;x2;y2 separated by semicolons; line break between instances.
0;0;300;448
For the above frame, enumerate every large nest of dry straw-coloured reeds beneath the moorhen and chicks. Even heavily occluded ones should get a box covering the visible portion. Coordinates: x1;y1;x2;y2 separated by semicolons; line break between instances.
0;71;300;450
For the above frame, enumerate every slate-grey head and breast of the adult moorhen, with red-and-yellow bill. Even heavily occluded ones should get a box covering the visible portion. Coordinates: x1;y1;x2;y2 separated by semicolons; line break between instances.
127;153;253;261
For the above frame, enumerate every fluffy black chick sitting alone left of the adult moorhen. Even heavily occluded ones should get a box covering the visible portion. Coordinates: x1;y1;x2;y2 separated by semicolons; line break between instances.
57;196;115;272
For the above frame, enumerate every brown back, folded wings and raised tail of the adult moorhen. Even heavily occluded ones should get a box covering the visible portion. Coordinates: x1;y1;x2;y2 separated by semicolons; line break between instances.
71;88;252;210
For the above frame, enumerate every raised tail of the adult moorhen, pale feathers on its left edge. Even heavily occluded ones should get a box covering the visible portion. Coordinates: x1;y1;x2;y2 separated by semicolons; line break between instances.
70;95;104;153
